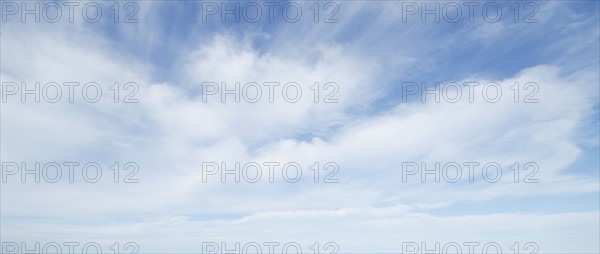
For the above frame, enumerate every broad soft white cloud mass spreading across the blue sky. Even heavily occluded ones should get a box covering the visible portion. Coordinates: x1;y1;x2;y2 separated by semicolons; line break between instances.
1;1;599;252
